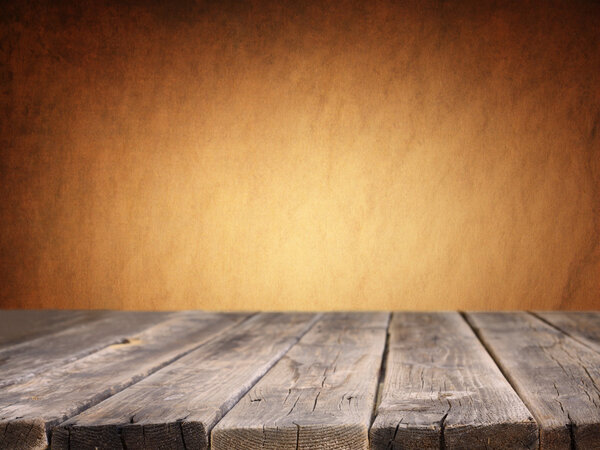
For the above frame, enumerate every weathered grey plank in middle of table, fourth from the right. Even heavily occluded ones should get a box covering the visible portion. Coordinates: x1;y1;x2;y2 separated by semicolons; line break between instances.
211;313;389;450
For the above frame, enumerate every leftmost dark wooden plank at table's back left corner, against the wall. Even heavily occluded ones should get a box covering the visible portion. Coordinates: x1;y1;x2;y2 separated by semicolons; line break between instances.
0;309;108;349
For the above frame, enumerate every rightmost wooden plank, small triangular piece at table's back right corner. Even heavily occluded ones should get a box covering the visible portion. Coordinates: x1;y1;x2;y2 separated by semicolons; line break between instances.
534;311;600;353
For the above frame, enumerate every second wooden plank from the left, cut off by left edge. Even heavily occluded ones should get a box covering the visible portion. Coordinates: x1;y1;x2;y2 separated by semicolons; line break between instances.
0;311;170;387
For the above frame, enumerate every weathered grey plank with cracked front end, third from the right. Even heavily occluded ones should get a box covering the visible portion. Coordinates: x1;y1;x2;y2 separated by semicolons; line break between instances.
371;312;538;449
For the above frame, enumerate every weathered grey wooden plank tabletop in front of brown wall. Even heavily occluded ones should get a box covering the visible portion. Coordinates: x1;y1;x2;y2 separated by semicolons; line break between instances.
0;311;600;450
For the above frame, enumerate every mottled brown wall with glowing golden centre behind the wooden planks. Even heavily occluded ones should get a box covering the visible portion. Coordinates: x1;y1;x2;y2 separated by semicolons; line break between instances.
0;0;600;309
